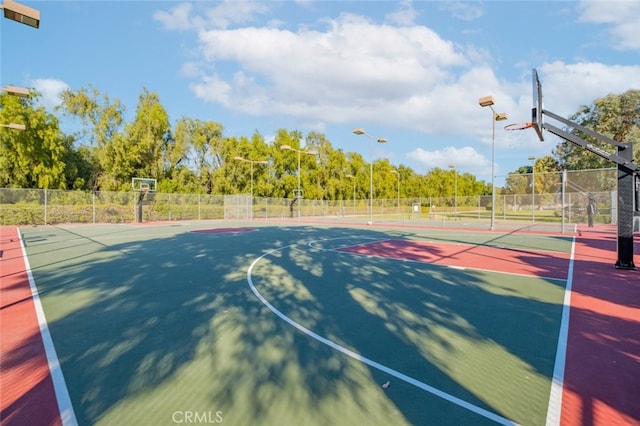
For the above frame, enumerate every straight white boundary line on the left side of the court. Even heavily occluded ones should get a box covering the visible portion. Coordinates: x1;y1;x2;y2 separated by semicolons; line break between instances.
18;230;78;426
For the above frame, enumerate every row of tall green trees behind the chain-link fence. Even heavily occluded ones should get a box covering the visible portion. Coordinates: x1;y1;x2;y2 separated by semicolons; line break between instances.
0;86;640;200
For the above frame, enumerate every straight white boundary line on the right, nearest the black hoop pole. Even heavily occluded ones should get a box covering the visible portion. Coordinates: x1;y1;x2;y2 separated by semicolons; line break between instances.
546;237;576;426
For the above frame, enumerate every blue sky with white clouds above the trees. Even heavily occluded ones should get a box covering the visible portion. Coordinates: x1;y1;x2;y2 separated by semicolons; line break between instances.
0;0;640;184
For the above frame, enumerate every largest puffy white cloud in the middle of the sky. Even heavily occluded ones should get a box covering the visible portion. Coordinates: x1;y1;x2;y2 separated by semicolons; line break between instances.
192;14;467;125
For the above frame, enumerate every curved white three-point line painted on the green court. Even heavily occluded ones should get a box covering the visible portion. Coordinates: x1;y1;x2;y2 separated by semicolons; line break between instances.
247;240;516;425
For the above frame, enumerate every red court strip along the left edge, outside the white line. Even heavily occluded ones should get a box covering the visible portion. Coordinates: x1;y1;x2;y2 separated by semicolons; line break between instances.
0;227;62;426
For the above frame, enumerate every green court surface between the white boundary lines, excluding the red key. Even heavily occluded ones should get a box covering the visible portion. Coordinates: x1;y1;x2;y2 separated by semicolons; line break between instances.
20;222;572;425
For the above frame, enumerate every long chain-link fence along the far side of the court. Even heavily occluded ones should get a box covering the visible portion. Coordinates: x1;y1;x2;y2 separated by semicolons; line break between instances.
0;169;617;227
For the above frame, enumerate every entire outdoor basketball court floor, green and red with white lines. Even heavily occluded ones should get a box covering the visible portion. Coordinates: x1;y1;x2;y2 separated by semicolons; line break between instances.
1;221;640;425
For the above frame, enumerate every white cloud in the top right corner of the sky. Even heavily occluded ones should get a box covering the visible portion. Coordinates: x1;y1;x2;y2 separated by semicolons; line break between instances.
579;0;640;50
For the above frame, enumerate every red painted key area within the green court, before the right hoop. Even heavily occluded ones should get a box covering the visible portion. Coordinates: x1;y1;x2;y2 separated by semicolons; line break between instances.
339;240;569;280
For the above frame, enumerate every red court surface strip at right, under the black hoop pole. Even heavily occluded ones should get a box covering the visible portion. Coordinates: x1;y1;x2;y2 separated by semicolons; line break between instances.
561;228;640;426
